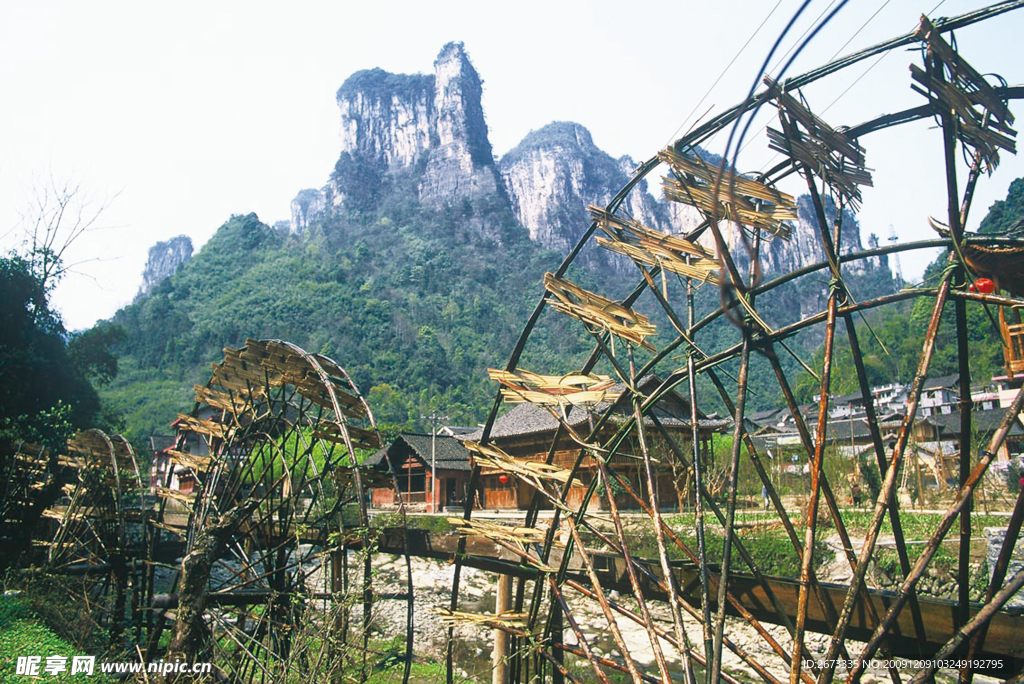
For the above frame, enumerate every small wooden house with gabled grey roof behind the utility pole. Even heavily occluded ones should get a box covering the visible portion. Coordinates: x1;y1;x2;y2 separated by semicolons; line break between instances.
365;432;472;512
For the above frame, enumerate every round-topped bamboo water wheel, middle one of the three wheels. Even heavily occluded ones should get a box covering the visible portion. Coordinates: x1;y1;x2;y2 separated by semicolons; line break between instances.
147;340;412;682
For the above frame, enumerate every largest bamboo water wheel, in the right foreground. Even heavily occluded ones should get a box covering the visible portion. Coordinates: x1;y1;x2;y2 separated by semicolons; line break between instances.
446;2;1024;684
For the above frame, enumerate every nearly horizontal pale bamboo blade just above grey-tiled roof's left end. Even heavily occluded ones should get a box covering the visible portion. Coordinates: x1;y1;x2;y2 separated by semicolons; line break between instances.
487;369;622;405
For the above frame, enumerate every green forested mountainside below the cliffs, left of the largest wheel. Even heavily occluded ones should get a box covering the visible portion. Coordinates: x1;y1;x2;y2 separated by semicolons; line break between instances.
103;179;598;442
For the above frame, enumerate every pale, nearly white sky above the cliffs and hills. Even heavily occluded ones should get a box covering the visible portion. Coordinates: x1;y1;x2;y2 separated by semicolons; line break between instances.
0;0;1024;328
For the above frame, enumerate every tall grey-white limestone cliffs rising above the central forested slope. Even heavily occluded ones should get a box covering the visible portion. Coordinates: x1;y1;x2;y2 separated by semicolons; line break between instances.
291;43;891;298
